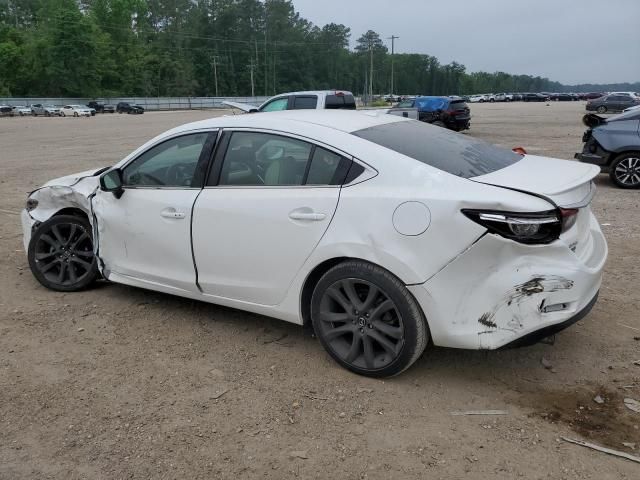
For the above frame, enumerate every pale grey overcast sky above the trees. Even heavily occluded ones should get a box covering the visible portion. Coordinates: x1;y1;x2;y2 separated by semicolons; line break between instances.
293;0;640;84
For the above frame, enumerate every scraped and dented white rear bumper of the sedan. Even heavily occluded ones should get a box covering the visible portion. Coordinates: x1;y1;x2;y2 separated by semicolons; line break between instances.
408;213;607;349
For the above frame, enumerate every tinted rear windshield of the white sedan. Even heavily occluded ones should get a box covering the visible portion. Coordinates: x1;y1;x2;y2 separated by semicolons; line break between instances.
353;120;522;178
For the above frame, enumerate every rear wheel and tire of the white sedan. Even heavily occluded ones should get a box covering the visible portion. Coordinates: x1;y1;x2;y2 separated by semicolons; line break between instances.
311;260;429;377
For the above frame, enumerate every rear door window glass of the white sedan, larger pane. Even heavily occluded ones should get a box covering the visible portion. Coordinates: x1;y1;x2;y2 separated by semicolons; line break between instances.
219;132;312;186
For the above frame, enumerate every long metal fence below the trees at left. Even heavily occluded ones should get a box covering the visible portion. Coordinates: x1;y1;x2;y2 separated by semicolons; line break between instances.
0;97;269;110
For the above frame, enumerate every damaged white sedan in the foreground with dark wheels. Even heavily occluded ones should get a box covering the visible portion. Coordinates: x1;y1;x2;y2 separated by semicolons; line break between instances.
22;110;607;376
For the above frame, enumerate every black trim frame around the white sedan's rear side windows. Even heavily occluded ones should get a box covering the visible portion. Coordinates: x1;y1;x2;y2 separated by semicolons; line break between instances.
203;127;364;190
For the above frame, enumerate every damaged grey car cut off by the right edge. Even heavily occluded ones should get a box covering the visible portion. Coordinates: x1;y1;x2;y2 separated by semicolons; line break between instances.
575;108;640;188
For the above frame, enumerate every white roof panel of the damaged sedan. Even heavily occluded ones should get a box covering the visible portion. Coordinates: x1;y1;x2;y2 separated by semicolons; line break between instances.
167;109;407;133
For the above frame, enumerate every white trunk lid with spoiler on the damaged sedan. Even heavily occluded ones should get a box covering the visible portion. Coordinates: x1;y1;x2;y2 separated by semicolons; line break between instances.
470;155;600;207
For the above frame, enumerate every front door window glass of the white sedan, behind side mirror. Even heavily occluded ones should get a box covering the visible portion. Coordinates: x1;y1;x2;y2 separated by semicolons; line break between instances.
123;133;209;187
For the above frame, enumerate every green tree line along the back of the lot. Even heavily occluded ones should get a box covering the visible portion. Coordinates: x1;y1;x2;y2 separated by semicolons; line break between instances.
0;0;640;97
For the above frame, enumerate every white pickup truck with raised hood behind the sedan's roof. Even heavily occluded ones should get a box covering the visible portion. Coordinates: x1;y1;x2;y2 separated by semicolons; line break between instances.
222;90;356;113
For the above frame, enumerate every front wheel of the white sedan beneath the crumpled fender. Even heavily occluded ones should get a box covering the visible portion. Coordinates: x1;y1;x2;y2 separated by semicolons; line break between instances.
27;215;99;292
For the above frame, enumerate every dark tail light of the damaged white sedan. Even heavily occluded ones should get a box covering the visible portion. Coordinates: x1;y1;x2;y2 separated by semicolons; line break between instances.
462;210;563;244
